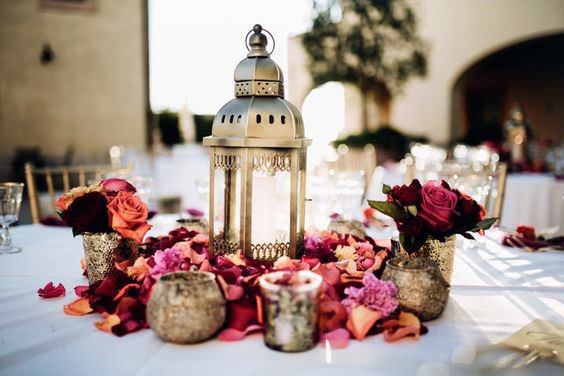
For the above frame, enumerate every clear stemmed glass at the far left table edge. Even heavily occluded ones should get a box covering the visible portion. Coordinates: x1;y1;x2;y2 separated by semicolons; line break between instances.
0;183;24;254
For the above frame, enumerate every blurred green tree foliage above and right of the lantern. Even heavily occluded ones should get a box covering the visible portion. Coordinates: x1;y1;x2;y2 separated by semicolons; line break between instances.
302;0;428;128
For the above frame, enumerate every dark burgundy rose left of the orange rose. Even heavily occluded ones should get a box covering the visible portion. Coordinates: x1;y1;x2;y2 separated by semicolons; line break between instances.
60;192;111;233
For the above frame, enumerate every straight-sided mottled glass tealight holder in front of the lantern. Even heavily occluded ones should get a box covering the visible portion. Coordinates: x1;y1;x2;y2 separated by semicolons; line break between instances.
259;270;322;352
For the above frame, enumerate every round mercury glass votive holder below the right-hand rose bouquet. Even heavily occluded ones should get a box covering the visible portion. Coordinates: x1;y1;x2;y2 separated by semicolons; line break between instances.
382;256;450;321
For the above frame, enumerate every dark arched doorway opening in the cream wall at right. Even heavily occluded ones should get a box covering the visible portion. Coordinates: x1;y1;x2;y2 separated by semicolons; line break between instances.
451;34;564;144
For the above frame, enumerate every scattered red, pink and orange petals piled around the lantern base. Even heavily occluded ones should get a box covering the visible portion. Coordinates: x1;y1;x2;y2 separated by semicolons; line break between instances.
45;228;427;348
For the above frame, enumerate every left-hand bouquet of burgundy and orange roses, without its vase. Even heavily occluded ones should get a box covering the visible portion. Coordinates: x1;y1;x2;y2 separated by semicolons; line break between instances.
55;178;151;243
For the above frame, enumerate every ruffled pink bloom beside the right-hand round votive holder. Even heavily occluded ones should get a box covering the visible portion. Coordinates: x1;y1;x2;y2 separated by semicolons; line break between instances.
342;273;398;318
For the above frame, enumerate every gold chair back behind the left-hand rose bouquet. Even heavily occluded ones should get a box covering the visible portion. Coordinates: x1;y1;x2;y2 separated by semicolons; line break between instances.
25;163;129;223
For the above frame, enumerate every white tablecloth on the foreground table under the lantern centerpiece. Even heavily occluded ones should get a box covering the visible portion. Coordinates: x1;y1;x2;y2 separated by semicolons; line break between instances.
0;225;564;376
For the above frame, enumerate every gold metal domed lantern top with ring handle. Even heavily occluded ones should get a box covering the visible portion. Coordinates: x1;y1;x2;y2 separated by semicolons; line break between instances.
204;24;310;148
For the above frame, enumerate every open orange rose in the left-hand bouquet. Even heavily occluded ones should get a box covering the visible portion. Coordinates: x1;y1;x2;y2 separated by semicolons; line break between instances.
108;191;151;243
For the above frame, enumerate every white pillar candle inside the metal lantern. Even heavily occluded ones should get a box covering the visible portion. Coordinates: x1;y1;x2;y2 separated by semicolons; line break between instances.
251;175;276;244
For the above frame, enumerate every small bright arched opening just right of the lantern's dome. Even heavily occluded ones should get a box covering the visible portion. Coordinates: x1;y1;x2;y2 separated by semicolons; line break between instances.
302;82;345;167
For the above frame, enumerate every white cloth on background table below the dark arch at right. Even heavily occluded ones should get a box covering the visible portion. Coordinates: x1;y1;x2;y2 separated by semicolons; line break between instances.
501;174;564;235
